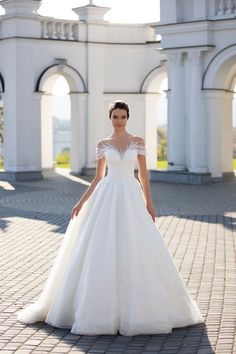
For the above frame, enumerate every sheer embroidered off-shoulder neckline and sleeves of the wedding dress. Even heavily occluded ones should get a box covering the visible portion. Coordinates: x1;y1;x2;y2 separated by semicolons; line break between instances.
96;136;146;159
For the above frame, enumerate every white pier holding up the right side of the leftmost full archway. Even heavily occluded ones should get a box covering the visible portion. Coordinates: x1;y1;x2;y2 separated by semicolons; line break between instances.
70;92;87;174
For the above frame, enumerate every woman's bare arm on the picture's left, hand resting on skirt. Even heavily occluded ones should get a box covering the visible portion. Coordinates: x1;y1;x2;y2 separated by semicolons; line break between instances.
71;150;106;218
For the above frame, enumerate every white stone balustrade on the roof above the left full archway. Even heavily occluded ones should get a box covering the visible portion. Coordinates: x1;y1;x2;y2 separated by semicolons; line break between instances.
41;18;78;41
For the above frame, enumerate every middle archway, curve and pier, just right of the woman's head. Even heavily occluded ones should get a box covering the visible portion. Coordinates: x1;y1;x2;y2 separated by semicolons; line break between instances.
140;62;167;170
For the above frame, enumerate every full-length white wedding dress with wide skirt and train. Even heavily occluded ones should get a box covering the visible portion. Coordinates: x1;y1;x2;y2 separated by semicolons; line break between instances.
17;136;204;336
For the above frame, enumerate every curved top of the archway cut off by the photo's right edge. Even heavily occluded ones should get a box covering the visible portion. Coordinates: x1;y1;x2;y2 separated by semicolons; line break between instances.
202;44;236;92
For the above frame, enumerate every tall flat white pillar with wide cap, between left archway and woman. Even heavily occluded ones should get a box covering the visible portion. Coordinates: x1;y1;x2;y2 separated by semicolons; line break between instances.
73;1;110;170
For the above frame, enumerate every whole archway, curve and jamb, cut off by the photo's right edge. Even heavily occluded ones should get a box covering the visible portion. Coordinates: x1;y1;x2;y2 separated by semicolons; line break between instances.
202;45;236;178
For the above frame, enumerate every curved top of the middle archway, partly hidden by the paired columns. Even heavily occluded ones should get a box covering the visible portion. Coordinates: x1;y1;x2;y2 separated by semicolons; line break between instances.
140;61;167;93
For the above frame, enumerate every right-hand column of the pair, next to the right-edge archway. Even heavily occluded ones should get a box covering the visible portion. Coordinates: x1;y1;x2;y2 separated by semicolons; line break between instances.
186;51;207;172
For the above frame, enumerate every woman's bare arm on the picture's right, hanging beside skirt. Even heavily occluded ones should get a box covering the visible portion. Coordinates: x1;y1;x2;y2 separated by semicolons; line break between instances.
138;141;156;222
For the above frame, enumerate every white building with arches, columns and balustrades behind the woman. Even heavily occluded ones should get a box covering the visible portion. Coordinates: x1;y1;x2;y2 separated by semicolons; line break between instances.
0;0;236;183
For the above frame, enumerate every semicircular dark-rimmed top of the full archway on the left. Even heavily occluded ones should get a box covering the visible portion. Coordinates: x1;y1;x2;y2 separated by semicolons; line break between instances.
35;64;87;93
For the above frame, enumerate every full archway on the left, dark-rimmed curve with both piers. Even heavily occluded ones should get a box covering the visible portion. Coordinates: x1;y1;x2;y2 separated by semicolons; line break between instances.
36;60;87;174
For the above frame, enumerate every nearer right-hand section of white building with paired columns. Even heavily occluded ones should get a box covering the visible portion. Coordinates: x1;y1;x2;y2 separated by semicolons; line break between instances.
155;0;236;178
